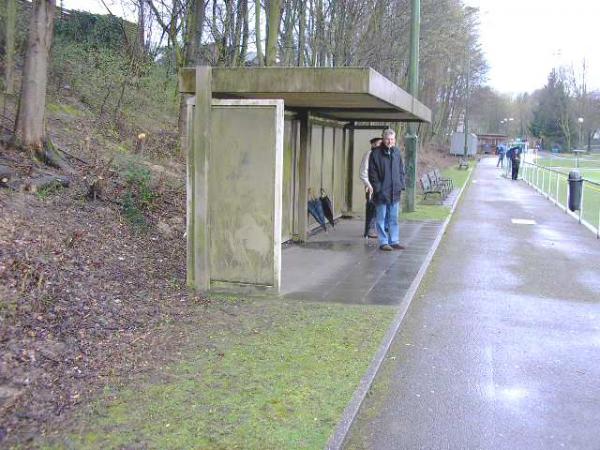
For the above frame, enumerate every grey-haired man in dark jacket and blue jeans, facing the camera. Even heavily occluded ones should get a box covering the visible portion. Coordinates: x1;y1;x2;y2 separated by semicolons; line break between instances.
369;129;405;251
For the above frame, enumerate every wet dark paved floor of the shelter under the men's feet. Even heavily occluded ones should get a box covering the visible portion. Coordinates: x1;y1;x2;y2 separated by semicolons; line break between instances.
280;218;442;305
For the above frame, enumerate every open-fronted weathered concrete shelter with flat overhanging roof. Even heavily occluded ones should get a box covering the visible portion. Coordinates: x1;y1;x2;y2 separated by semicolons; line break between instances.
179;66;431;293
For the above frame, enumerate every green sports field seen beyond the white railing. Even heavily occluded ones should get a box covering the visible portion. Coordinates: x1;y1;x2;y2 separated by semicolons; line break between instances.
528;153;600;228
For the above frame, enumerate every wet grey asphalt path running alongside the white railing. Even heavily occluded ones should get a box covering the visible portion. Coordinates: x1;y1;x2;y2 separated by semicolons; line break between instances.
346;159;600;450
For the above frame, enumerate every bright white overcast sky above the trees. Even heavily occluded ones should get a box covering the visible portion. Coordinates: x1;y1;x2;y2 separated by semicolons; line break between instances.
65;0;600;94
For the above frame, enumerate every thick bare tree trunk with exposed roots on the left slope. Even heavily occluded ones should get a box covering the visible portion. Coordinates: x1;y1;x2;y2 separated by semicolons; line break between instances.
14;0;56;160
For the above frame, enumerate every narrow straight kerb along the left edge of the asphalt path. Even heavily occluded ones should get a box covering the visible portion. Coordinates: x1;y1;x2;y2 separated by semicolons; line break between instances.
325;167;475;450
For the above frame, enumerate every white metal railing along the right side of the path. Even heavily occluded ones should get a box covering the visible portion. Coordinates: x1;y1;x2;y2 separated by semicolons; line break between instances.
521;161;600;238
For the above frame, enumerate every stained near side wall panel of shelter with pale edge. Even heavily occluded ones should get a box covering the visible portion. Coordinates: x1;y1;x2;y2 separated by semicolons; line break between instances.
208;100;289;290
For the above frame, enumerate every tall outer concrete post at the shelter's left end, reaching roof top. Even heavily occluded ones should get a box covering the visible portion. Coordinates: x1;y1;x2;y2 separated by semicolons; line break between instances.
187;66;212;291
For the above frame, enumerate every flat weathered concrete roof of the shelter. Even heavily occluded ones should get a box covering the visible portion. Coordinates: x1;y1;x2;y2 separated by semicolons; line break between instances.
179;67;431;122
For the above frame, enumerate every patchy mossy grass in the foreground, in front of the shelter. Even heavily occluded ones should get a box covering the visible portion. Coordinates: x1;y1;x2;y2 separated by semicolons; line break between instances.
46;299;395;449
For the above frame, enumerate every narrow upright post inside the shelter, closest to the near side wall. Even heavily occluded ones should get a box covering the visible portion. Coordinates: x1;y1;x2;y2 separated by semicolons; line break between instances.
294;111;312;242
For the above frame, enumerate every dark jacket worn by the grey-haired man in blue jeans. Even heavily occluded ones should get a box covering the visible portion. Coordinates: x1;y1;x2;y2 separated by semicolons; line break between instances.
369;146;405;205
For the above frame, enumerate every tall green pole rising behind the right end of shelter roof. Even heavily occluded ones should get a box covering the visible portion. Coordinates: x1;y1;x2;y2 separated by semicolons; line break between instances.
405;0;421;212
